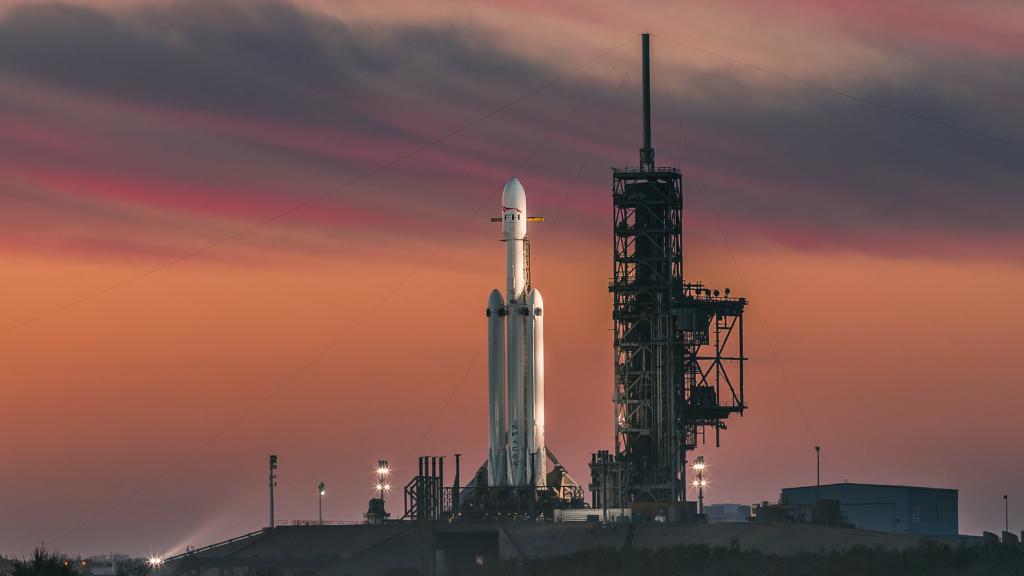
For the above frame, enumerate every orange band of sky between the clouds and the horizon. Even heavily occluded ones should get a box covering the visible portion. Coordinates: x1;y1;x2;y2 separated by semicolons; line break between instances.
0;235;1024;551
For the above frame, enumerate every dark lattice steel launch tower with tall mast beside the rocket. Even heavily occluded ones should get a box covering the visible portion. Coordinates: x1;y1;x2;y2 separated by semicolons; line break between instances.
606;34;746;506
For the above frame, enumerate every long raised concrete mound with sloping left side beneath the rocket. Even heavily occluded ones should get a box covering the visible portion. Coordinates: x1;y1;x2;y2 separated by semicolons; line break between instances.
165;522;966;576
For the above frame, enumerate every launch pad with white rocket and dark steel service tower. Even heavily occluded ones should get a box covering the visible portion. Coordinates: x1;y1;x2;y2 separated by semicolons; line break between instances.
395;34;746;522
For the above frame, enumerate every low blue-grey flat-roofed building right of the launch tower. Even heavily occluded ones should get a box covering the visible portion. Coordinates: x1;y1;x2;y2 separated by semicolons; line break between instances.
780;483;959;536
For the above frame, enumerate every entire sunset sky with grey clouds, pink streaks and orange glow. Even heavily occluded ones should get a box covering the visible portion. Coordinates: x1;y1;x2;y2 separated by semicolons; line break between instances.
0;0;1024;554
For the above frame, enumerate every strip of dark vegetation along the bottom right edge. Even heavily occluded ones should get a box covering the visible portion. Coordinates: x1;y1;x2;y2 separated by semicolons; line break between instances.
489;542;1024;576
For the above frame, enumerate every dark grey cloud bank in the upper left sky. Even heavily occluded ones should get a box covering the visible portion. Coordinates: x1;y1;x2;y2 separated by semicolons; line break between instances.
0;1;544;135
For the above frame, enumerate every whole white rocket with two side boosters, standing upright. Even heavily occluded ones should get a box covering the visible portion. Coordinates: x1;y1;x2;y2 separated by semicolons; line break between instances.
487;177;547;488
